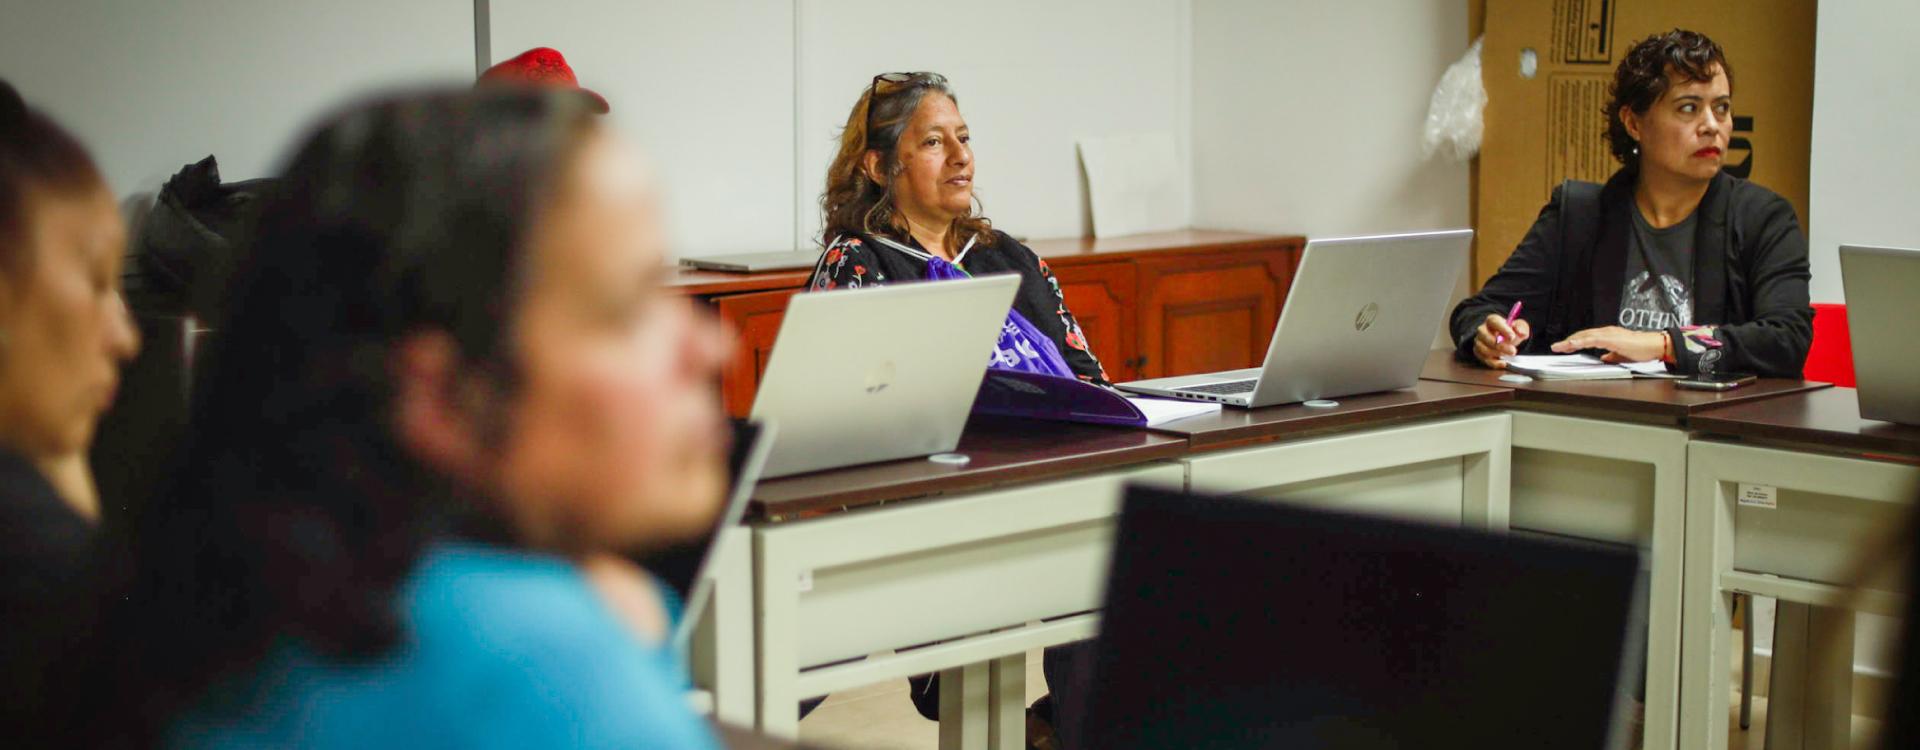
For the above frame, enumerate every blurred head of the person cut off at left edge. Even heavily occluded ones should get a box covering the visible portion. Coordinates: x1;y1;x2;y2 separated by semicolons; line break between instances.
0;81;140;494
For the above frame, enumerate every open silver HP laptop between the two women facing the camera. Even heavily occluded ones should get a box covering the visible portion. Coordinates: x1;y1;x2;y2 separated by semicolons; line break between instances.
1119;228;1473;407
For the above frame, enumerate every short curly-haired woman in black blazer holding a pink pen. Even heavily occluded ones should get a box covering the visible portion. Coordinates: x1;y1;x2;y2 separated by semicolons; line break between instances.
1452;29;1812;378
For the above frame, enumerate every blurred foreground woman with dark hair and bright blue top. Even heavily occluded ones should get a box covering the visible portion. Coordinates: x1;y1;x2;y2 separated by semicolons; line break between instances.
46;88;728;748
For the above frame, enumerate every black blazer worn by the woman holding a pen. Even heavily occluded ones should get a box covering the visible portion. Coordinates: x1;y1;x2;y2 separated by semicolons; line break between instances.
1452;169;1812;378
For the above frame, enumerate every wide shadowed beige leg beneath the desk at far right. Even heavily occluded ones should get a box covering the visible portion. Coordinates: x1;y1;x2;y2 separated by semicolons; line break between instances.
1766;600;1853;750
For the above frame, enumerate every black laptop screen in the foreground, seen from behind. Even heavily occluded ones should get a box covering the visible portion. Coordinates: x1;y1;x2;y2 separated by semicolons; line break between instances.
1077;487;1644;750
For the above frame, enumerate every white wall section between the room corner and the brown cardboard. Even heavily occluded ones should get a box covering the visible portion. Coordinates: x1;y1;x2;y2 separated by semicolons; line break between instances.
1192;0;1471;236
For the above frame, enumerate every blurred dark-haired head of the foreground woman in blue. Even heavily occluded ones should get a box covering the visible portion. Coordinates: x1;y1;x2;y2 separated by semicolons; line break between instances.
78;88;728;744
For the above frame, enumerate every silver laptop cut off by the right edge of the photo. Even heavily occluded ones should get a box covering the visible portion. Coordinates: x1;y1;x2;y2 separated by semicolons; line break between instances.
1839;246;1920;424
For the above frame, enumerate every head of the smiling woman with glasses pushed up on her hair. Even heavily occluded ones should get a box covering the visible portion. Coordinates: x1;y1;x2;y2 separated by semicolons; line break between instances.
820;73;993;249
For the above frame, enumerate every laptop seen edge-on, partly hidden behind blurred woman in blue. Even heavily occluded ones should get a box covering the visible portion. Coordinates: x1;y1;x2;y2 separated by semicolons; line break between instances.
639;422;774;650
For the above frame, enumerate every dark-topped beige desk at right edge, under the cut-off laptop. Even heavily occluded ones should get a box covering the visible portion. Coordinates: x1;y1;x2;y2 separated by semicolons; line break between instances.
1682;387;1920;748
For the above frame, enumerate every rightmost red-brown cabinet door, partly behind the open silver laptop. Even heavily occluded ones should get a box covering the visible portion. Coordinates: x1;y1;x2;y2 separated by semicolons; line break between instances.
1135;246;1298;378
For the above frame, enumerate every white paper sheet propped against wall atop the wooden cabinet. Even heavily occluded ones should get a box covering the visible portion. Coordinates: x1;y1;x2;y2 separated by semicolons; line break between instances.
1079;132;1187;238
